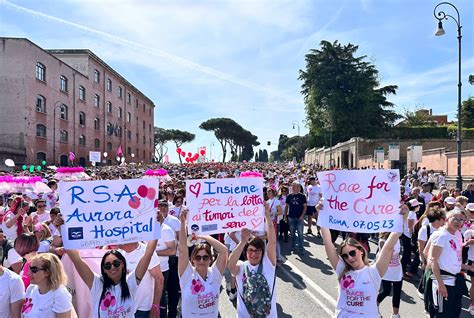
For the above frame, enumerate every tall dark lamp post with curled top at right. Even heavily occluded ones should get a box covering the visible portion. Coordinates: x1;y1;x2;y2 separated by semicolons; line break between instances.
433;2;462;189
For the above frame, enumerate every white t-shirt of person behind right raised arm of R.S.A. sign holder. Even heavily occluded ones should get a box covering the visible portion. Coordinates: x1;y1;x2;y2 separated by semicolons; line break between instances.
120;243;160;312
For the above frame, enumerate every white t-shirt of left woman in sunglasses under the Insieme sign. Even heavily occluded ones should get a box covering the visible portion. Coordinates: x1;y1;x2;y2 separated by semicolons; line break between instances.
179;263;222;318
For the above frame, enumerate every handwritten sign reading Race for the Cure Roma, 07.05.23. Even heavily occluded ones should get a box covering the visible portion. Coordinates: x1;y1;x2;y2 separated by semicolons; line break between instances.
318;170;403;233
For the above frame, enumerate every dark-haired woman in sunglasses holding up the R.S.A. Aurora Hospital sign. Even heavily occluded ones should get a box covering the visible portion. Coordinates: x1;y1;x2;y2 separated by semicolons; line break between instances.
66;240;157;318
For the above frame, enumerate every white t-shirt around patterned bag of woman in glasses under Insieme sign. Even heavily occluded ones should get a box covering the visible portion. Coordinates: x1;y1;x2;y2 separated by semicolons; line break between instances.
235;251;278;318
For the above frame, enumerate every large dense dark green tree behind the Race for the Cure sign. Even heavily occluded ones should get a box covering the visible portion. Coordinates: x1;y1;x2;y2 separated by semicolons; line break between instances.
299;41;400;146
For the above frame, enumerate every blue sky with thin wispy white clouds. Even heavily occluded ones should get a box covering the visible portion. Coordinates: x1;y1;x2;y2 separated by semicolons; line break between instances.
0;0;474;161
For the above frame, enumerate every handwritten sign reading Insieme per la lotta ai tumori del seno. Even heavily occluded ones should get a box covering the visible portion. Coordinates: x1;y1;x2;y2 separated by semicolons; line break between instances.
186;178;265;235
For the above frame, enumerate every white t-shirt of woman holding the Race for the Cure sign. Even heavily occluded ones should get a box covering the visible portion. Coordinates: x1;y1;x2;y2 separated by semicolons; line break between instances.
336;259;382;318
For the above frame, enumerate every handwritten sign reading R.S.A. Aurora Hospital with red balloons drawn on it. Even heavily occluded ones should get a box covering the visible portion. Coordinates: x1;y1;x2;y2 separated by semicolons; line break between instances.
59;179;161;249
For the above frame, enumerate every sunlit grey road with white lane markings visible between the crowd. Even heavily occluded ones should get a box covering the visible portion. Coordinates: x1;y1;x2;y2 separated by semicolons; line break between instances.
219;227;471;318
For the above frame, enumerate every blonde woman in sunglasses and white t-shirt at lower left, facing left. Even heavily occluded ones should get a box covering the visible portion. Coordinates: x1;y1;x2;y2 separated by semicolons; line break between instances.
21;253;74;318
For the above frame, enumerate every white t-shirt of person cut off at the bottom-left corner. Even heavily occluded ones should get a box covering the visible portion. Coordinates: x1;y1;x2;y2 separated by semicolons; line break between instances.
0;265;25;318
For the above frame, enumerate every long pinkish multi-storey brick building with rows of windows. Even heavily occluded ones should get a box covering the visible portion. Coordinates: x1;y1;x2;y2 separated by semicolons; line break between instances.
0;38;155;166
